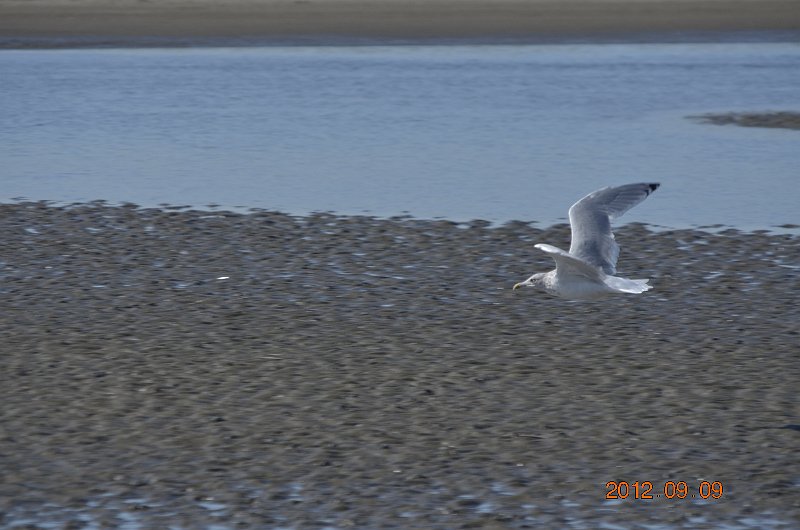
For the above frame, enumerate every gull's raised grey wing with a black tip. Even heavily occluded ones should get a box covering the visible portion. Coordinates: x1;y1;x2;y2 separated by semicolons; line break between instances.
569;182;660;275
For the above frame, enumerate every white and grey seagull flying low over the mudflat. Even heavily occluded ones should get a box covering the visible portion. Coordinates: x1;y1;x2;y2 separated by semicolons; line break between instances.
514;182;661;300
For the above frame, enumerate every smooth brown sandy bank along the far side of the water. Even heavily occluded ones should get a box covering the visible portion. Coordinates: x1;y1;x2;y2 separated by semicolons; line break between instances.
0;0;800;48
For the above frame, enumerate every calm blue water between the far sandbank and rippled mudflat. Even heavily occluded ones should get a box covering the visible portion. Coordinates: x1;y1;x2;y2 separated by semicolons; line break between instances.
0;42;800;229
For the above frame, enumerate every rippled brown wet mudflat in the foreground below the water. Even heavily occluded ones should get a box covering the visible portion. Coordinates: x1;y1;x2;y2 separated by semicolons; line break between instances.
0;203;800;530
